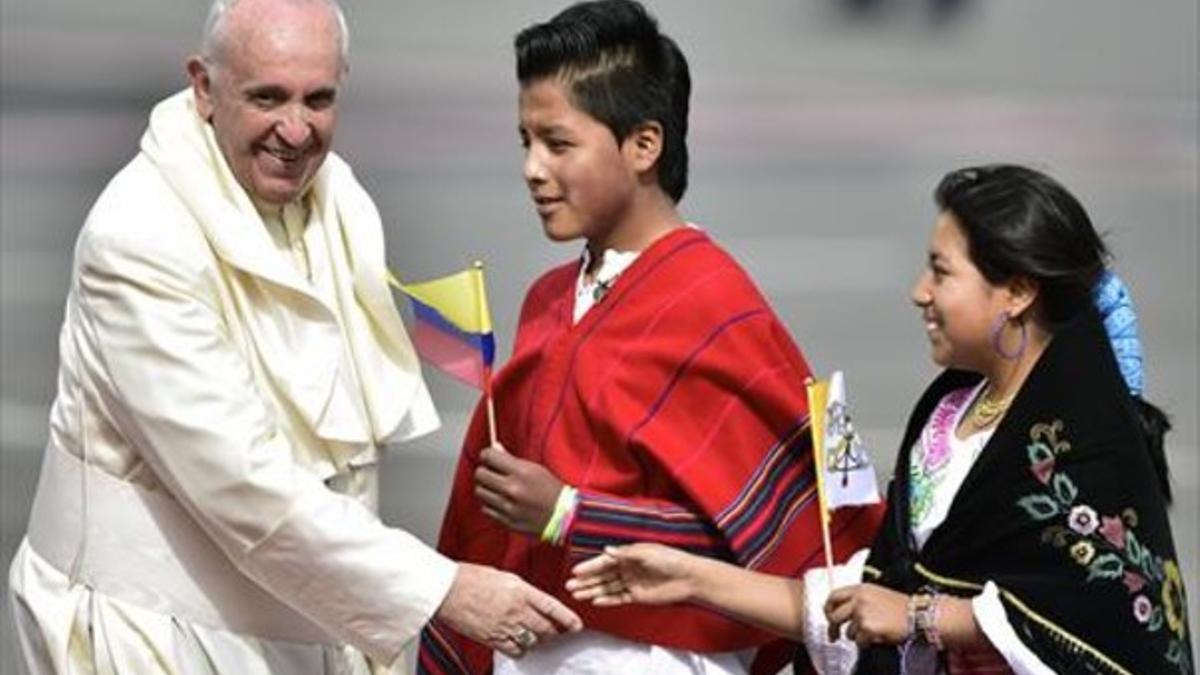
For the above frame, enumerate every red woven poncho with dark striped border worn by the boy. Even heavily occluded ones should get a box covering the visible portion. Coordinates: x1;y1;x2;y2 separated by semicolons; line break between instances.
419;228;878;673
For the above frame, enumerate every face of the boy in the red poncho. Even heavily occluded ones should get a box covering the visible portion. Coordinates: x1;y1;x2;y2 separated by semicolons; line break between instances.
520;78;637;243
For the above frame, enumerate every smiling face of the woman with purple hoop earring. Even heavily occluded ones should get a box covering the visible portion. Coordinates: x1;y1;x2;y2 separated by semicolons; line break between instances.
912;211;1015;372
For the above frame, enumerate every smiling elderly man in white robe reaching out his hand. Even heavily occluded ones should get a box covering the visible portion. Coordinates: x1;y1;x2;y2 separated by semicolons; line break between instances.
10;0;578;674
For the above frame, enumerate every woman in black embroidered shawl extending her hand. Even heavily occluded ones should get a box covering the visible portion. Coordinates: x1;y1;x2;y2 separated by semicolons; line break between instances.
574;166;1194;675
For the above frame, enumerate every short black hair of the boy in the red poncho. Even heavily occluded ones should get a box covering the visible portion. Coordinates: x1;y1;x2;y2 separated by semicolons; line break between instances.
514;0;691;202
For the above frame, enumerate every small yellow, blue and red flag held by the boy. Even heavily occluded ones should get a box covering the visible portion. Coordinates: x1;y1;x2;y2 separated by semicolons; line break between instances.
388;263;496;390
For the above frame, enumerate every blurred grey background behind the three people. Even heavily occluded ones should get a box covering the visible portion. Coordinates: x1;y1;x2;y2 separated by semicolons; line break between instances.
0;0;1200;673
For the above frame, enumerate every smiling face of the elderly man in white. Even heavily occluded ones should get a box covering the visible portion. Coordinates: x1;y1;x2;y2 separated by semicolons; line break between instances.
188;0;344;204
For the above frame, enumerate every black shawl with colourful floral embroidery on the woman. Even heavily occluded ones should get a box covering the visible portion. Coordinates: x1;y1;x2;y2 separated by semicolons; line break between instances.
857;311;1194;675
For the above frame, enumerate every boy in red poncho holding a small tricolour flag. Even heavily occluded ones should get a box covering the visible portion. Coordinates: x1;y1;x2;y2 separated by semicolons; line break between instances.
419;0;878;675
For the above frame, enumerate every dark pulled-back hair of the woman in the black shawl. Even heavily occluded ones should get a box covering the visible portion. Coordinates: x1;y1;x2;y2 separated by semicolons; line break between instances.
934;165;1171;502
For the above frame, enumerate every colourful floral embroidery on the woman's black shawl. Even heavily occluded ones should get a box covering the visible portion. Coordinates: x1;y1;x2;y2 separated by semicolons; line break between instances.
1016;419;1193;674
